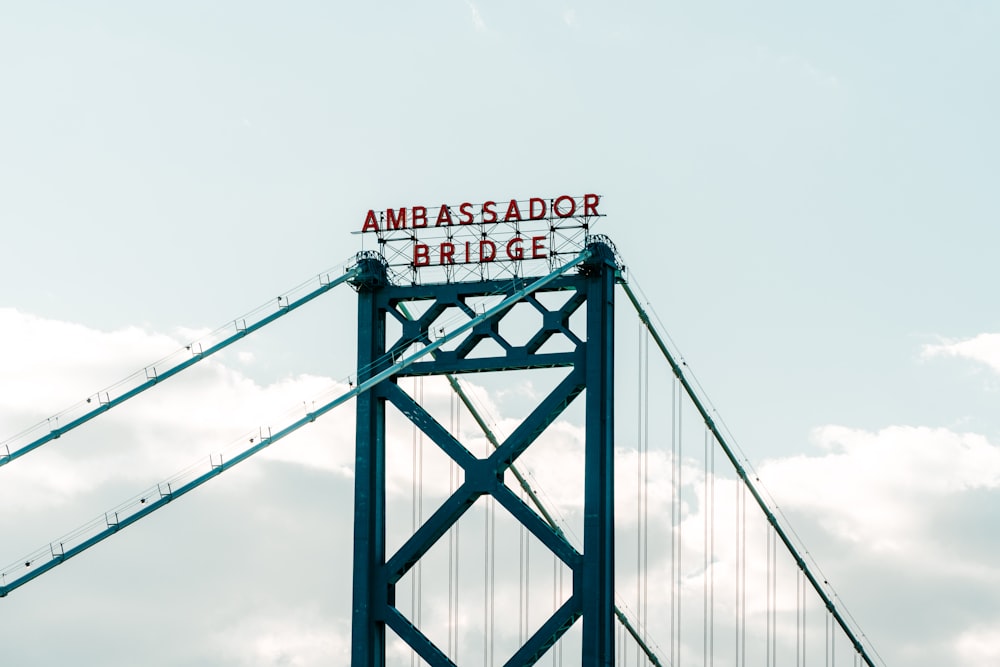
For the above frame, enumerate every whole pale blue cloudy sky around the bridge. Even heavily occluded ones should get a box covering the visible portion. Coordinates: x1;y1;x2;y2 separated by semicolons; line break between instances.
0;0;1000;667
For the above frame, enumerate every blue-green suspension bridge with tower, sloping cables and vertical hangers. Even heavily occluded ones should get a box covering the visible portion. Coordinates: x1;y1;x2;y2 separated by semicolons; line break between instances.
0;200;884;667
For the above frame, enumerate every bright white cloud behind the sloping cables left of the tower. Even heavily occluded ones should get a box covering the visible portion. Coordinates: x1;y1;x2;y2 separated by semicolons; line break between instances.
0;309;353;516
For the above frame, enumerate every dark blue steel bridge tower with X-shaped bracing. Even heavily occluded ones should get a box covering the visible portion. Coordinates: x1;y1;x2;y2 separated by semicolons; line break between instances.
351;237;621;667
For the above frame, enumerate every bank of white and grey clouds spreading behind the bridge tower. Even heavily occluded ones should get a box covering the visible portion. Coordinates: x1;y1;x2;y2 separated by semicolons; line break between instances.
0;309;1000;665
